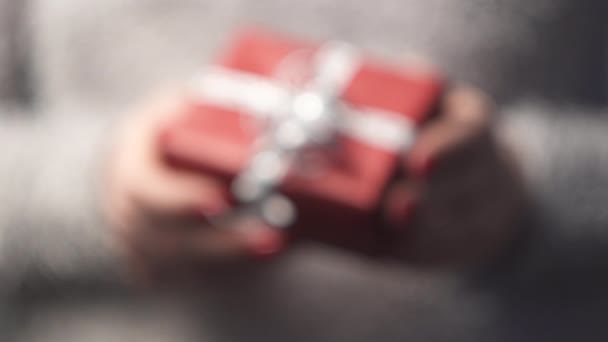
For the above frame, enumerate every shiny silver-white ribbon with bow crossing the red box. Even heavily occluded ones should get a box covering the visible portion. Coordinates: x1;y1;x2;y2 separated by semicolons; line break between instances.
193;43;415;227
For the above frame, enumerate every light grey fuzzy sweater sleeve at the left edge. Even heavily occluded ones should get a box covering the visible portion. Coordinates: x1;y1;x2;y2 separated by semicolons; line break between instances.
0;109;127;289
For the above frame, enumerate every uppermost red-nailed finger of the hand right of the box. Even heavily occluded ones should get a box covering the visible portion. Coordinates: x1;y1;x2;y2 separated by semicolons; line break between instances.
405;87;490;177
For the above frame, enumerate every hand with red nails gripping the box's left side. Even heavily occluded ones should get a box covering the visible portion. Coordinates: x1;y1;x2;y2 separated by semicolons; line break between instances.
104;92;282;281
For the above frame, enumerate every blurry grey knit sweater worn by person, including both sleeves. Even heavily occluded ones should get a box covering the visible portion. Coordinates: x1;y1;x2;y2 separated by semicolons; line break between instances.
0;0;608;341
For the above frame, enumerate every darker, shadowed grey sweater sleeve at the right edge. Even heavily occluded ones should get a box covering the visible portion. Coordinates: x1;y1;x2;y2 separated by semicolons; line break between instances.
501;103;608;291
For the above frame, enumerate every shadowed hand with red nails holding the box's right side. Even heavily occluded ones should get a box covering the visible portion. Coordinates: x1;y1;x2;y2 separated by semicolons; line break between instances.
385;87;524;266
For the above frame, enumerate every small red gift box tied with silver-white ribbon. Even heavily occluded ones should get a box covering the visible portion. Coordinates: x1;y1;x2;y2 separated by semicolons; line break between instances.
162;30;443;253
